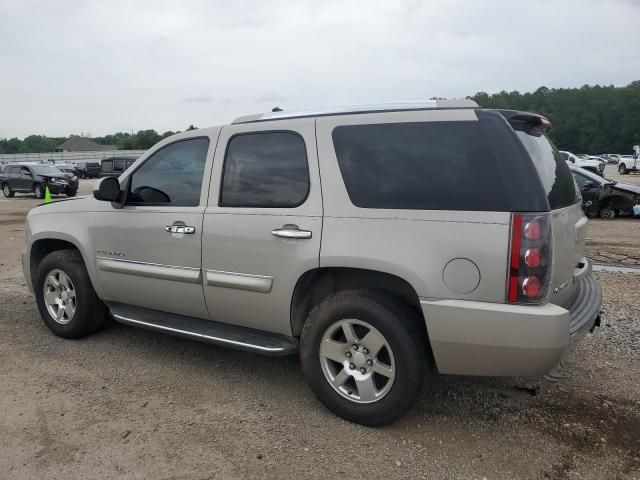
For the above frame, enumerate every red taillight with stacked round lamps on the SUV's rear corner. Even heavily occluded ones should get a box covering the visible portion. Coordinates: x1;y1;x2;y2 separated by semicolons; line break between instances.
507;213;552;303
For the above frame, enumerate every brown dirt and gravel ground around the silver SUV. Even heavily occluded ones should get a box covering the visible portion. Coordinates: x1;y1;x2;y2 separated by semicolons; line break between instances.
0;177;640;479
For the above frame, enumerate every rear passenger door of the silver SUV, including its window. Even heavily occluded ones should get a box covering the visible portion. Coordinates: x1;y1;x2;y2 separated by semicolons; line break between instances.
202;119;322;335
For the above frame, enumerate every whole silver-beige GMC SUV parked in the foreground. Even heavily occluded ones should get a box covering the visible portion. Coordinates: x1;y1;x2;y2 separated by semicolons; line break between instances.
23;101;601;425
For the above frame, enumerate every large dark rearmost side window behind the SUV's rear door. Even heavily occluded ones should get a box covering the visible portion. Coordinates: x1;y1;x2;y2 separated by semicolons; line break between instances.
333;122;508;211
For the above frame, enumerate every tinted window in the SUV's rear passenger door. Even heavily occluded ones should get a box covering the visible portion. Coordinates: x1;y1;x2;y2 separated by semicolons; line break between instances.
220;132;309;208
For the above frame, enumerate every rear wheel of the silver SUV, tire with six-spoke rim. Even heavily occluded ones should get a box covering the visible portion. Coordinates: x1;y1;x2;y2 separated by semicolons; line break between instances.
300;290;433;426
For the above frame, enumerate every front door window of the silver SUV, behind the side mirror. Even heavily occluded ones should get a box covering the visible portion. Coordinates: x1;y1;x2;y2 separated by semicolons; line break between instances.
128;138;209;207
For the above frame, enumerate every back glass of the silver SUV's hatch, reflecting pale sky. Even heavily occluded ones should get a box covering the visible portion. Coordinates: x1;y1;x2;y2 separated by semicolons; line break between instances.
512;128;578;210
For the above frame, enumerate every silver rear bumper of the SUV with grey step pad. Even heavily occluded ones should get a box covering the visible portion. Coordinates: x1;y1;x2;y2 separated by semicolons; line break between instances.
420;273;602;376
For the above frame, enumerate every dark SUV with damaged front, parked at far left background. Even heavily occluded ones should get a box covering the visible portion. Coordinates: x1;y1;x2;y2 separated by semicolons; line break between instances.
0;164;78;198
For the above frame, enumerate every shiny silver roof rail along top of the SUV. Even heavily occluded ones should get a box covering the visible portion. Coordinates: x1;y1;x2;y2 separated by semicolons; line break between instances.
231;98;479;123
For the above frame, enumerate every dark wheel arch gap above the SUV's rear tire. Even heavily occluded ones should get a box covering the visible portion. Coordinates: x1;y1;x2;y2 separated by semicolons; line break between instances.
290;267;426;336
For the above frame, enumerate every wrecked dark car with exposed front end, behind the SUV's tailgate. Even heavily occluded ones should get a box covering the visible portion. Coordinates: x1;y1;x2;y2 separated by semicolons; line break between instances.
569;165;640;219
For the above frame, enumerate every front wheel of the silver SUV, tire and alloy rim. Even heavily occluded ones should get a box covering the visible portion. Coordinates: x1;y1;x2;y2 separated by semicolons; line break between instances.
34;250;109;338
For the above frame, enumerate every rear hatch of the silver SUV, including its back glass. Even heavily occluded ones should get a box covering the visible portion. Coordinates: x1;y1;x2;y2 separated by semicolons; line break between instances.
510;122;587;306
